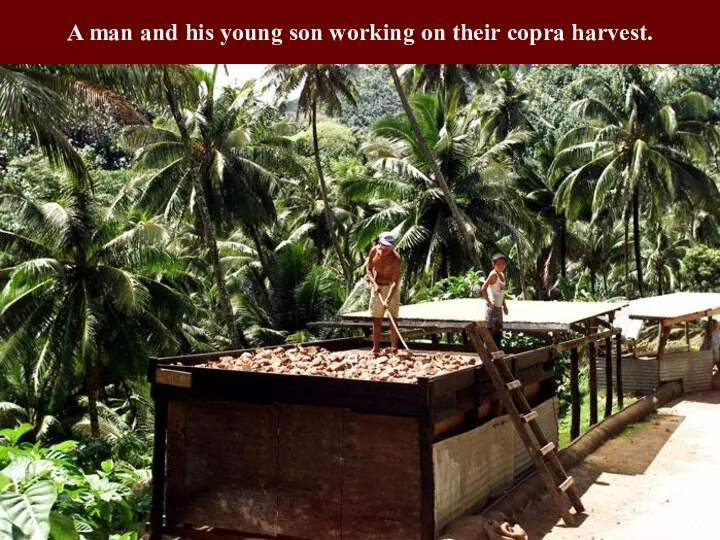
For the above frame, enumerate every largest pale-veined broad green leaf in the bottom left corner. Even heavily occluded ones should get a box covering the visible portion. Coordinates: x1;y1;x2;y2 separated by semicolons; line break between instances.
0;481;57;540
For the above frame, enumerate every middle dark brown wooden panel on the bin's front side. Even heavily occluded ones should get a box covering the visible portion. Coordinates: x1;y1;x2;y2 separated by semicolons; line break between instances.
278;405;343;540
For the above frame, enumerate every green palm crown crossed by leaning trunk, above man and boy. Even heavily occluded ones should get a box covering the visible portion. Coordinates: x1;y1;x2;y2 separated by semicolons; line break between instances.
372;84;526;277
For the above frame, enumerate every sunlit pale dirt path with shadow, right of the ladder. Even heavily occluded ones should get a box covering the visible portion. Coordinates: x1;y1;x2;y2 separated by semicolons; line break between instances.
516;391;720;540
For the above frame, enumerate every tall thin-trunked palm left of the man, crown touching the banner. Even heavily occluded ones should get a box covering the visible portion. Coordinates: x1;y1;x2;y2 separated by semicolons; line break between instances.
263;64;357;290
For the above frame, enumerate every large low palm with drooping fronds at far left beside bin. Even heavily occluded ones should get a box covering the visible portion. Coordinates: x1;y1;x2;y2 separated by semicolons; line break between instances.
0;183;191;435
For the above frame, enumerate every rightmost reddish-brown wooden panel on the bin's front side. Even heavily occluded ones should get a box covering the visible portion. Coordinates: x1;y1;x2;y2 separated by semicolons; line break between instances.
342;412;421;540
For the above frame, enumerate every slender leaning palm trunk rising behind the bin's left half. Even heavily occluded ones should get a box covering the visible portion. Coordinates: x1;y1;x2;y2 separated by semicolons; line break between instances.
164;67;248;349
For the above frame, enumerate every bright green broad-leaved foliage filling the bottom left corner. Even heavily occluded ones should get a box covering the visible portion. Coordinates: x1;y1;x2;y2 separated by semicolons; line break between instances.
0;424;149;540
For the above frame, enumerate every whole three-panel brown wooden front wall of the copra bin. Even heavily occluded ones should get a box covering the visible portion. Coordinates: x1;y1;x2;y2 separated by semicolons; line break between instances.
167;399;423;540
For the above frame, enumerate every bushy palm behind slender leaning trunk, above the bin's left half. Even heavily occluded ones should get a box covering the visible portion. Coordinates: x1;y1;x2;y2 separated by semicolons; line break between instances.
125;74;299;308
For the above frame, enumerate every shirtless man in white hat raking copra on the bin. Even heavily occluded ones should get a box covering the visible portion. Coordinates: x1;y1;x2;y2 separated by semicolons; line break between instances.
367;232;401;354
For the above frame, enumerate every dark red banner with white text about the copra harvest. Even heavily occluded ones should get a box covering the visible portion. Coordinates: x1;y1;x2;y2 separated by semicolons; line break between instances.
0;0;718;63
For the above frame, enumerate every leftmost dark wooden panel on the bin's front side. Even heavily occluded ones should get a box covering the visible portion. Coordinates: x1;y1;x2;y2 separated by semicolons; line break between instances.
176;400;278;535
